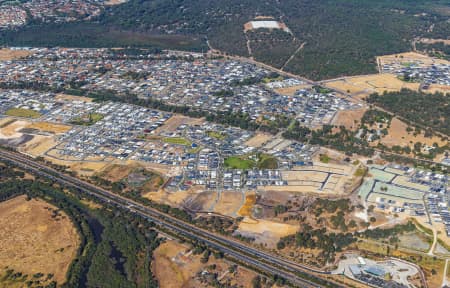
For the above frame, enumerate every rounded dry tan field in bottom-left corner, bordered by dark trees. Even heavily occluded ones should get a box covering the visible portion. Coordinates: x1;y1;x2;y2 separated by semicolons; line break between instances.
0;196;80;287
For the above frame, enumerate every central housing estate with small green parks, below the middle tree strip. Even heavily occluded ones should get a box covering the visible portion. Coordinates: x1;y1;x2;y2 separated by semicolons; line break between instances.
0;90;331;195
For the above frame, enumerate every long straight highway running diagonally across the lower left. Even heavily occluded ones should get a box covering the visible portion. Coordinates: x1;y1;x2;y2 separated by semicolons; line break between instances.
0;149;342;288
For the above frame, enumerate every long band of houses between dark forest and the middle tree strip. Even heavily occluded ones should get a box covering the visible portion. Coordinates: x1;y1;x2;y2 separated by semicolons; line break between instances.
0;49;360;126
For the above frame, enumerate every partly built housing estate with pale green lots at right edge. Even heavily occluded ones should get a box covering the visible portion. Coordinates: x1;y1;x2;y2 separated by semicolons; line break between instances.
359;164;450;235
